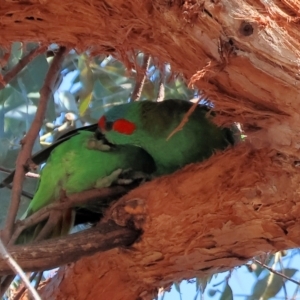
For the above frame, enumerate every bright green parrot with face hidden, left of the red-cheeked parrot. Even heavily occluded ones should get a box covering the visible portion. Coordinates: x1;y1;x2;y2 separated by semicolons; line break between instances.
16;131;155;244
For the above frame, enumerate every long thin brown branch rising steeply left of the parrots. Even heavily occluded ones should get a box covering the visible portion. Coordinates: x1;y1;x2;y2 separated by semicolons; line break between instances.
2;47;66;243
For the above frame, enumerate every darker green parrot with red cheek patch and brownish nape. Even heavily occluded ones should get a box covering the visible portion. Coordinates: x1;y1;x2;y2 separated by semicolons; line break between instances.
98;100;234;175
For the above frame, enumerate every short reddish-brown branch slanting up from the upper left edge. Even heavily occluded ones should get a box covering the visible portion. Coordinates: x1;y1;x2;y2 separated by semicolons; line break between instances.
0;46;47;90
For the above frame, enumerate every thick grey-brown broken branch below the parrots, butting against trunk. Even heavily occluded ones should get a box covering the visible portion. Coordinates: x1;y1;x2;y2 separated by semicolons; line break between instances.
0;222;140;275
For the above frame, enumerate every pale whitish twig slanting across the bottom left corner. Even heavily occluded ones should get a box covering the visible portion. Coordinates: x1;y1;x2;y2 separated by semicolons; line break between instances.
0;239;42;300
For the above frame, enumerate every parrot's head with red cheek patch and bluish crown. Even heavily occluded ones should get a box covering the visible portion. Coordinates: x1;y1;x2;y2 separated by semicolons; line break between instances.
98;102;141;146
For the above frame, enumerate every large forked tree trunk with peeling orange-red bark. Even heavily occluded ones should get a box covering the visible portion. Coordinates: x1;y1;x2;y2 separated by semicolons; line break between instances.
0;0;300;299
